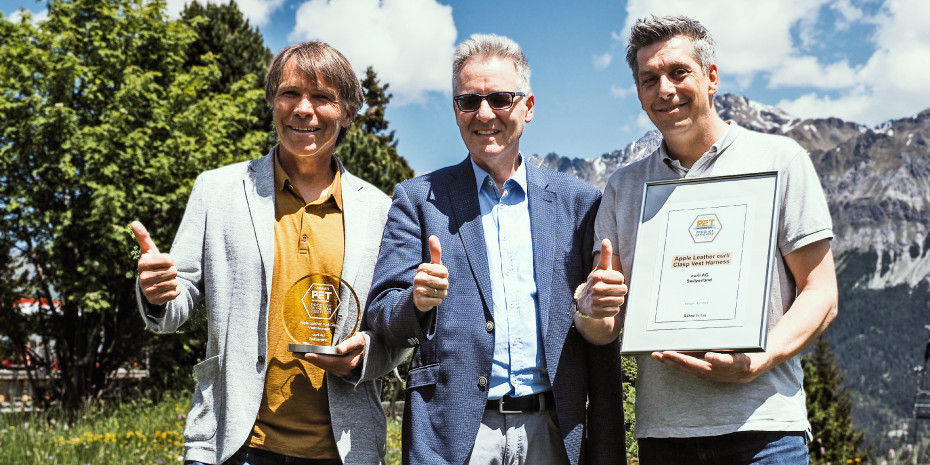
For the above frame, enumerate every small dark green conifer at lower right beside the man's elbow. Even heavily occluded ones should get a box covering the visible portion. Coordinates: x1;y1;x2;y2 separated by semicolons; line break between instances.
801;337;868;464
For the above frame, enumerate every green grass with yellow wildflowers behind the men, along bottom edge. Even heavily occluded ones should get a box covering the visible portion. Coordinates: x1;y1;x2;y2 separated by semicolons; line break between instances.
0;393;928;465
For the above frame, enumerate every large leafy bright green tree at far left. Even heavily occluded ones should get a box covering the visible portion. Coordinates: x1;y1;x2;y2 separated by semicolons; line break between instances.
0;0;266;408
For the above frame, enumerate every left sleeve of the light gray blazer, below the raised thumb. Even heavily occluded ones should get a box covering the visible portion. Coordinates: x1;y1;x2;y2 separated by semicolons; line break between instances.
136;174;206;333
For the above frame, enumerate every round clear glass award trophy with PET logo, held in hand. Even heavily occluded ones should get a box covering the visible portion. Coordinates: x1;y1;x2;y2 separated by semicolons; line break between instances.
284;274;361;354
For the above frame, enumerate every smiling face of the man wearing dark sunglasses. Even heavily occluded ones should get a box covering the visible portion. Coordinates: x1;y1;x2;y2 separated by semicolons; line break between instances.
452;55;535;173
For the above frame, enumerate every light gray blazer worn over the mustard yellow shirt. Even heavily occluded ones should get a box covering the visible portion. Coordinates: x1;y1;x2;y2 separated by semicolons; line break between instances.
136;149;406;464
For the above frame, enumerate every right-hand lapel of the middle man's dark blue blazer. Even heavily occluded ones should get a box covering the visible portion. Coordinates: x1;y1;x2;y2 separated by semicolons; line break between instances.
524;160;556;337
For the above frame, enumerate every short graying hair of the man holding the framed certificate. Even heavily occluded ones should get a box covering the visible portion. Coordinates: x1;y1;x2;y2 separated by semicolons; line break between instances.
626;16;717;87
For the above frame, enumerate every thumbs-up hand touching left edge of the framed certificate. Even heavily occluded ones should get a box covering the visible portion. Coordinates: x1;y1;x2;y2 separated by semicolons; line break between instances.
575;239;627;319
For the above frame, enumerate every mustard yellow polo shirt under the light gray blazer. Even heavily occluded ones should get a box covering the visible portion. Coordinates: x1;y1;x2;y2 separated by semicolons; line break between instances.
249;153;345;459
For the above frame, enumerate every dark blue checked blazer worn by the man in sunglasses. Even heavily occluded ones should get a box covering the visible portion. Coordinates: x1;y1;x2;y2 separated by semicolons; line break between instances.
367;159;625;465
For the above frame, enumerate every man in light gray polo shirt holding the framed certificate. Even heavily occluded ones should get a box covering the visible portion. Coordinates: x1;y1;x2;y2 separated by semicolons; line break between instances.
576;17;837;465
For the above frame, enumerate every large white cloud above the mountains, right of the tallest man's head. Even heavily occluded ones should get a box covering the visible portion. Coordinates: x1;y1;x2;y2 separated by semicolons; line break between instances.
623;0;930;124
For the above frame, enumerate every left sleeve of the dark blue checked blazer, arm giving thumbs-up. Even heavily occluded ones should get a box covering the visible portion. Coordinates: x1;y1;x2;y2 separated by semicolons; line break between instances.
367;183;435;347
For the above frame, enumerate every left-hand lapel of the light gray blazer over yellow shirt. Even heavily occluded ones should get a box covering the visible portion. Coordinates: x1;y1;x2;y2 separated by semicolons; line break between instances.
243;148;275;295
